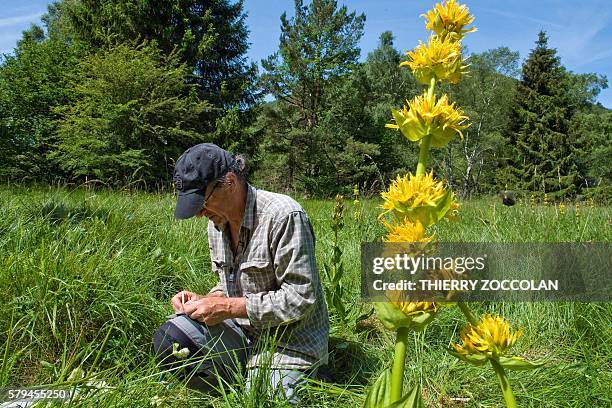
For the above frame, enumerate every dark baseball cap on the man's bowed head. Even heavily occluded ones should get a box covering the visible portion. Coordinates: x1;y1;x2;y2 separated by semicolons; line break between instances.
174;143;235;219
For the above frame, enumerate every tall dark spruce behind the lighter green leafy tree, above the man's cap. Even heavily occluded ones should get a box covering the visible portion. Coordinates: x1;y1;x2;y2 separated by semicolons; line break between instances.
54;0;257;149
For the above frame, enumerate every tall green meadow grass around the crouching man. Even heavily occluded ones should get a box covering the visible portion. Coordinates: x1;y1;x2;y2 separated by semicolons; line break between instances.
0;186;612;408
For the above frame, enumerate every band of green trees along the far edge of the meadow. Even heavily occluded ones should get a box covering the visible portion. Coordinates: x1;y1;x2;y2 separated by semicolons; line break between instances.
0;0;612;200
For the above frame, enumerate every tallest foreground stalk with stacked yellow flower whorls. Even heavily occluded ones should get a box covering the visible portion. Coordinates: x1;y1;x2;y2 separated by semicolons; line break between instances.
365;0;476;407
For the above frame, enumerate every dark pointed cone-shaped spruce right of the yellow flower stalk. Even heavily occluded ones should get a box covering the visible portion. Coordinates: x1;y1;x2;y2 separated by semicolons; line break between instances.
504;31;583;199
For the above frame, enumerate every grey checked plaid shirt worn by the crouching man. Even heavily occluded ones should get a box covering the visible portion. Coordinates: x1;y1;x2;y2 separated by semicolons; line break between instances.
208;184;329;368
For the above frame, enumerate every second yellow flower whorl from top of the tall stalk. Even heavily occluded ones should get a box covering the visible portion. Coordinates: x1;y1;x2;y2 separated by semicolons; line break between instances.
400;36;467;85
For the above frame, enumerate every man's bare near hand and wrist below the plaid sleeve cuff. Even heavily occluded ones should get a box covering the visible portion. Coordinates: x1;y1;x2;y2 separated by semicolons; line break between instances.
184;292;247;326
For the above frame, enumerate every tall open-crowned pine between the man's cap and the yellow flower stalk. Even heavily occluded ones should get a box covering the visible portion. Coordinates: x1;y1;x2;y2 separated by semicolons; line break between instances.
259;0;365;192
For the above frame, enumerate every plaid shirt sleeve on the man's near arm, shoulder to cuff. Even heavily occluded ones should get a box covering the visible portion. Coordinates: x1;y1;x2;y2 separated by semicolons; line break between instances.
246;211;319;328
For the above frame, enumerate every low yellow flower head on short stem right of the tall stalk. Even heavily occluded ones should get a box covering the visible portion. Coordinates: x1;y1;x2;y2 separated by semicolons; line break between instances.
453;315;523;358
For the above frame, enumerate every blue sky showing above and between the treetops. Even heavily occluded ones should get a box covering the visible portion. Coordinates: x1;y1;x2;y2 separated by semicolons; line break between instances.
0;0;612;108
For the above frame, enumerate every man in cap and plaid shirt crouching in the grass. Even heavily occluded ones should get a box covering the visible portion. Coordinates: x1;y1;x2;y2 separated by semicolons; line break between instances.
154;143;329;403
